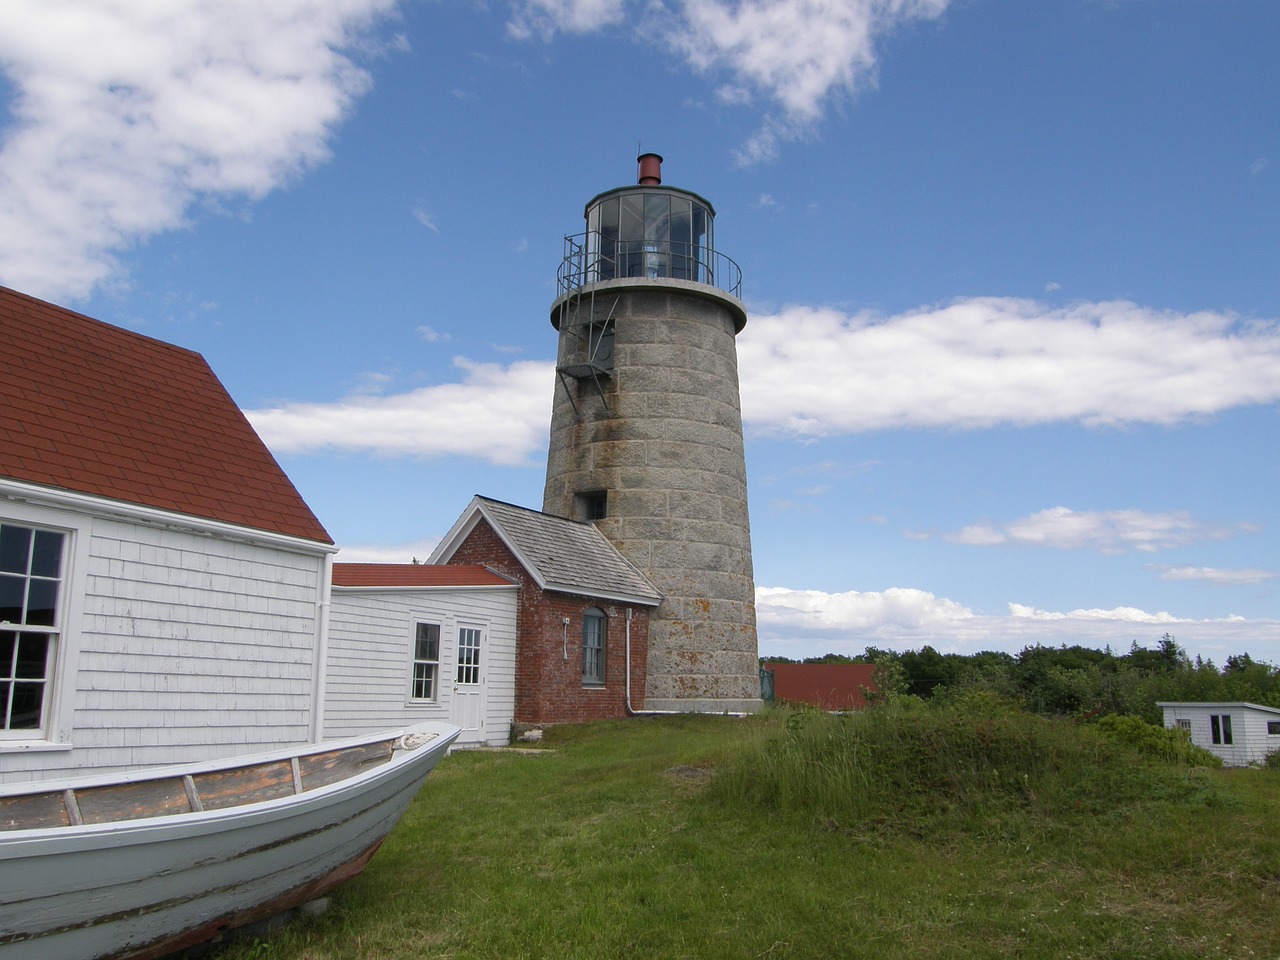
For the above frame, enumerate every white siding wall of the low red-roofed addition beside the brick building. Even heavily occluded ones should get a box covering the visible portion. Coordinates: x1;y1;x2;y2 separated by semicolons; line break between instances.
325;586;517;746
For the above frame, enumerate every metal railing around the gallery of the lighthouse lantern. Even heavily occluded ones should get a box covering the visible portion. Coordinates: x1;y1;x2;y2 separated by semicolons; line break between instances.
556;233;742;300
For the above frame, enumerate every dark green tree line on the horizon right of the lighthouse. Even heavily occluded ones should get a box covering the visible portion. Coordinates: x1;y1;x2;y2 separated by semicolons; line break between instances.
762;634;1280;724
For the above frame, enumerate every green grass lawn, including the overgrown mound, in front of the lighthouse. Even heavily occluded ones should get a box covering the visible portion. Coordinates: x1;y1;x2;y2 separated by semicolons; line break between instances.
218;708;1280;960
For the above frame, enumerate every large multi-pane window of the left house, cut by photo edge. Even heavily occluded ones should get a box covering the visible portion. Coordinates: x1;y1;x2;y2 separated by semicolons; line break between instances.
0;524;67;740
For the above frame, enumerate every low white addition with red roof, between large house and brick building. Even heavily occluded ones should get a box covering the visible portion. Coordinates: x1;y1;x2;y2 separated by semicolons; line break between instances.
324;563;520;746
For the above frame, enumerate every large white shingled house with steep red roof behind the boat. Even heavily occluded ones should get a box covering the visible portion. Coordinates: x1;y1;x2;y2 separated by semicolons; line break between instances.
0;281;335;783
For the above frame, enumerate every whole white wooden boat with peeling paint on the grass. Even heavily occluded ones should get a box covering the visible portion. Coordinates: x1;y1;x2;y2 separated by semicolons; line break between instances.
0;722;461;960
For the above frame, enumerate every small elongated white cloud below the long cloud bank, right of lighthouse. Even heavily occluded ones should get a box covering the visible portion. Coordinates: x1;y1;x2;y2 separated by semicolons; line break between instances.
946;507;1235;554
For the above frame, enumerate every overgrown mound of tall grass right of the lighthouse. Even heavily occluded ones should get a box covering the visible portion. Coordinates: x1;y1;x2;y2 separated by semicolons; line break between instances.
713;699;1221;835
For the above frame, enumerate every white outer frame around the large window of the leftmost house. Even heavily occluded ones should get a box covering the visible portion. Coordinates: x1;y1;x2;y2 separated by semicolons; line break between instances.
0;494;93;755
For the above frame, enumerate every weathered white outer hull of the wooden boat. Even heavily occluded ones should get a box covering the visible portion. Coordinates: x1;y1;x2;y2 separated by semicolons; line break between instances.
0;724;458;960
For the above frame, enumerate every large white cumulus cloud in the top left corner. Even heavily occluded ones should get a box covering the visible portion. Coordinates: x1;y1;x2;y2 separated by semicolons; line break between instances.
0;0;396;300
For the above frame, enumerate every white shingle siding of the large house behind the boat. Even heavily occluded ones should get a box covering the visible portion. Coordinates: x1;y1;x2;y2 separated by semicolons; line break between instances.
0;504;325;782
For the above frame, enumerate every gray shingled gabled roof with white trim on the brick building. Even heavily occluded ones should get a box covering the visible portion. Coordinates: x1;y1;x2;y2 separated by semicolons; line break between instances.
428;497;662;607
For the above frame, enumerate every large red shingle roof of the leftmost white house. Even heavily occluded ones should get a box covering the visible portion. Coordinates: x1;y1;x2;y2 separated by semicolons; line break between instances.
0;287;333;543
